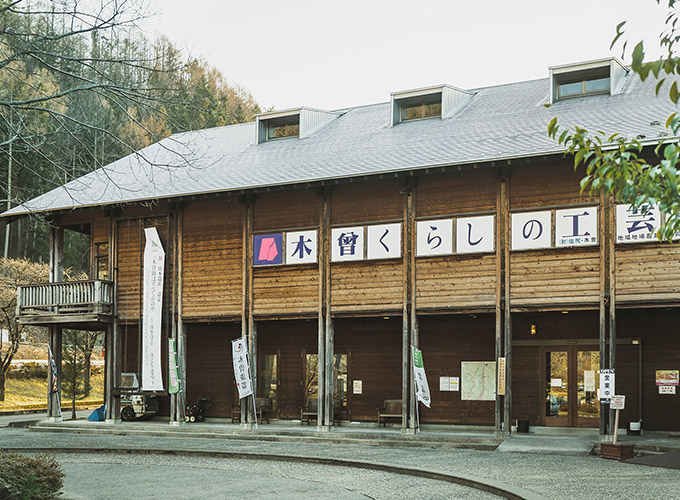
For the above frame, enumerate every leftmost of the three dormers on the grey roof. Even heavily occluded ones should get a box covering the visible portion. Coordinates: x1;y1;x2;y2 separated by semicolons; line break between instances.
255;108;341;144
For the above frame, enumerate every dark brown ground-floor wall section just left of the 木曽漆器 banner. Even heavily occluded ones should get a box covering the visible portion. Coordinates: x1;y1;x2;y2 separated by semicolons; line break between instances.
186;323;241;418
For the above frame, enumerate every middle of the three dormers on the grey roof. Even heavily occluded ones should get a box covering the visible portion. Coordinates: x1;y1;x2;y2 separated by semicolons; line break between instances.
390;85;474;126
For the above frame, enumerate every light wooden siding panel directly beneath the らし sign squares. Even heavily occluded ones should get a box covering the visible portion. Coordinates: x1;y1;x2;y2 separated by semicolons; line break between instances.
416;255;496;309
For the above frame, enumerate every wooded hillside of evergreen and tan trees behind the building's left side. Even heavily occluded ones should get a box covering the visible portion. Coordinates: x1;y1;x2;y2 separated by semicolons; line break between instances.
0;0;260;261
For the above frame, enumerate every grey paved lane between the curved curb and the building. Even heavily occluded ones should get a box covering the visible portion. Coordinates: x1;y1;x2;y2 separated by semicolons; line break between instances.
0;428;680;500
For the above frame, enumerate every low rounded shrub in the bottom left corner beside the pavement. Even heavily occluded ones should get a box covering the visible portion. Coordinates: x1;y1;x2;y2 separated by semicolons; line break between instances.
0;450;64;500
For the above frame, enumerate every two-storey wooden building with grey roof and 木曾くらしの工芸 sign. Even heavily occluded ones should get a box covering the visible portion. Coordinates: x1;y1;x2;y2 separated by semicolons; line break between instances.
4;59;680;433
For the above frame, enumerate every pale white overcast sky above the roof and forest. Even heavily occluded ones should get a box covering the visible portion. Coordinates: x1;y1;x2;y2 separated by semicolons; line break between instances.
142;0;666;110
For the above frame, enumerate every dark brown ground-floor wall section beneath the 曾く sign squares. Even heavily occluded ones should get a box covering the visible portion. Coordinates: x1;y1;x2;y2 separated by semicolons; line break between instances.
334;316;404;422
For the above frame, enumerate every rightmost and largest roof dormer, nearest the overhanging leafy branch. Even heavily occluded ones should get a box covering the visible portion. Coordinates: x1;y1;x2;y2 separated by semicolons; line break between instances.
549;57;629;104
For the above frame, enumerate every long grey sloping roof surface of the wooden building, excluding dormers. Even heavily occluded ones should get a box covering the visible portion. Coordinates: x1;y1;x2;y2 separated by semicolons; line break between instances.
3;71;676;215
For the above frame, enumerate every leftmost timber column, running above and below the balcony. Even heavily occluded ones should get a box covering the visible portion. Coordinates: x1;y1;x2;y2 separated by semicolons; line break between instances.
47;227;64;422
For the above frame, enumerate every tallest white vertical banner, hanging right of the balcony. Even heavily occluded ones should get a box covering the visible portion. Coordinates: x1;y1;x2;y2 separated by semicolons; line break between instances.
142;227;165;391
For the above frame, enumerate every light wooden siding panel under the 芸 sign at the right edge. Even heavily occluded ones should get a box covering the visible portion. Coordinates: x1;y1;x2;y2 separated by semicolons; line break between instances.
616;243;680;304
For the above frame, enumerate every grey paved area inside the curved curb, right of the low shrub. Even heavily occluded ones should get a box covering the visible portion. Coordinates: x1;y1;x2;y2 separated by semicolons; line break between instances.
50;454;498;500
